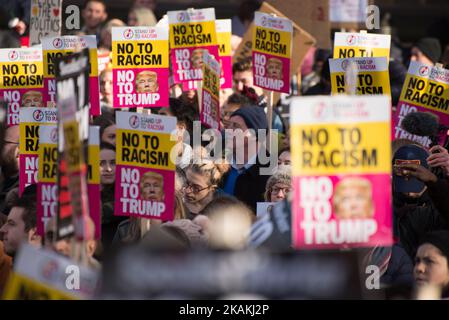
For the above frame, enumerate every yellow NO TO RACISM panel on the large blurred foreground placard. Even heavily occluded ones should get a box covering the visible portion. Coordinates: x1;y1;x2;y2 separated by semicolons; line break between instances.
290;122;391;176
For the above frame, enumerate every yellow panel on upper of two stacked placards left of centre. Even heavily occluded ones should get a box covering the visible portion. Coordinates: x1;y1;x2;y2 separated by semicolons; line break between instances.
112;40;169;69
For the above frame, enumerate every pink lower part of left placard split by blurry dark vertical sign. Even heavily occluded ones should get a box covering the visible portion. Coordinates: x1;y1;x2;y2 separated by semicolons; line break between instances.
37;182;101;240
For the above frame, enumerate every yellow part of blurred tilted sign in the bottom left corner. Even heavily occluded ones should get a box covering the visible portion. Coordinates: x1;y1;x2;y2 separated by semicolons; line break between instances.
3;273;76;300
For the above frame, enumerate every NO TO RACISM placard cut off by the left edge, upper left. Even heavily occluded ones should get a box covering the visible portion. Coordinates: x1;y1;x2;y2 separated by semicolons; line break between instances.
0;48;49;126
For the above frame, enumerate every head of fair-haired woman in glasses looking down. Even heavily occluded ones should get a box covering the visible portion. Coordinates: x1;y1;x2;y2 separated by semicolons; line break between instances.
182;160;229;219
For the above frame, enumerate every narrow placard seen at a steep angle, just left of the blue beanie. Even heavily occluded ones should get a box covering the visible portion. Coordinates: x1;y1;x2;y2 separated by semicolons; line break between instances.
200;52;221;130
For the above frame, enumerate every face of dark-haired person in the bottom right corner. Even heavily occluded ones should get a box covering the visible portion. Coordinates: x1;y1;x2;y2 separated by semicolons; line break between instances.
413;243;449;287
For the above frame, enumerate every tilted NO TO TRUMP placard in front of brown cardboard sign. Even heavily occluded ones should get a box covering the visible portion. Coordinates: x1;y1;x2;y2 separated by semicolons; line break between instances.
252;12;293;93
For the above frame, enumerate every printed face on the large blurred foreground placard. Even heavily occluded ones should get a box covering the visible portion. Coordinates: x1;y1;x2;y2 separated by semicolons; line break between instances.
335;186;372;219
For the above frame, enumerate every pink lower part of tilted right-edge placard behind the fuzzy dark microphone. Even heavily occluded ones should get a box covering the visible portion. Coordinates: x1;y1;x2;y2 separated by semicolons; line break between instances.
391;101;449;147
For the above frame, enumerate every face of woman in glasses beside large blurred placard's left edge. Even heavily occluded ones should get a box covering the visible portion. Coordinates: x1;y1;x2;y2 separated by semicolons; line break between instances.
265;165;292;202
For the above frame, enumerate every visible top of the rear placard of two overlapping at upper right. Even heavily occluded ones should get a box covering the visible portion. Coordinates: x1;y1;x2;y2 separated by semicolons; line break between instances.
334;32;391;61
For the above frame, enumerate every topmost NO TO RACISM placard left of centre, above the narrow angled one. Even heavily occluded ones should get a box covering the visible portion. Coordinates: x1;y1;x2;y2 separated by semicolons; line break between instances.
167;8;219;83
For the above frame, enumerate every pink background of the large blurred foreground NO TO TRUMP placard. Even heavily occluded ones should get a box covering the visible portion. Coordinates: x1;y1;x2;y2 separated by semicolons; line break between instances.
292;174;393;249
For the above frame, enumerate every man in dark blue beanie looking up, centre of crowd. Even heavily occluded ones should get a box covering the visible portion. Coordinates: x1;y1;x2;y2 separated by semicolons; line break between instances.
224;106;269;211
